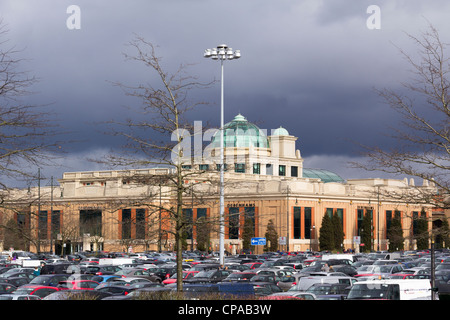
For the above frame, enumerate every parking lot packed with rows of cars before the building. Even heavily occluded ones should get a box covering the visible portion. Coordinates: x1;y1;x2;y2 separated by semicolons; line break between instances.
0;250;450;301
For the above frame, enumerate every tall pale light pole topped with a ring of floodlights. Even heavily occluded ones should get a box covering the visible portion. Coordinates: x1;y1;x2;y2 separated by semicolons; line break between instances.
204;44;241;266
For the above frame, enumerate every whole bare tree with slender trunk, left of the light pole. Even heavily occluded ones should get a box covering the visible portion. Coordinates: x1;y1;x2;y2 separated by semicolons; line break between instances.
100;37;216;291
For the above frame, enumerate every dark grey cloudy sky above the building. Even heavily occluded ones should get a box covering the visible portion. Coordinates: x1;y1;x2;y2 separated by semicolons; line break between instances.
0;0;450;186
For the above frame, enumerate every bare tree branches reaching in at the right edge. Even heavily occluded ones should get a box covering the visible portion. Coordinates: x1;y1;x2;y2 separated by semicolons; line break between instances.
352;25;450;203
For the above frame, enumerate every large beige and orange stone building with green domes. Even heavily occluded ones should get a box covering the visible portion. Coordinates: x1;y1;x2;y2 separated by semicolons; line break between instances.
2;115;442;252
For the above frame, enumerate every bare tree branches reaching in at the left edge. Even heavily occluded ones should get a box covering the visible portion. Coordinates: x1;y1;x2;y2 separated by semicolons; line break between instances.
0;21;58;194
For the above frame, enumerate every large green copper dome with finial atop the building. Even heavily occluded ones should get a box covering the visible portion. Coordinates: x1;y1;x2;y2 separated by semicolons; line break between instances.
211;114;269;148
